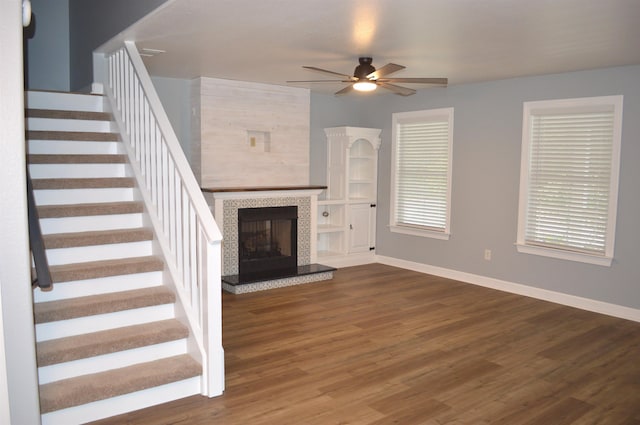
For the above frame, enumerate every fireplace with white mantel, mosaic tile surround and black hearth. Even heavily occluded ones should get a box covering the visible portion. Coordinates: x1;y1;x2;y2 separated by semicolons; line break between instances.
203;186;335;294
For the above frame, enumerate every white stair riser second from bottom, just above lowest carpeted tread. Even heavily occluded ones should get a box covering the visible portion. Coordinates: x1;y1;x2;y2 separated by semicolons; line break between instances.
38;338;187;385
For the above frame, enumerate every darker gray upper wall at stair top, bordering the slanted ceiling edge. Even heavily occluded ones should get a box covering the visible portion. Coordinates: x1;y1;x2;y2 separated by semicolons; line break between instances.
69;0;166;90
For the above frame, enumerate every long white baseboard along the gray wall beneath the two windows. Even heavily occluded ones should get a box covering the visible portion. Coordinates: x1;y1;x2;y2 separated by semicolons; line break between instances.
376;255;640;322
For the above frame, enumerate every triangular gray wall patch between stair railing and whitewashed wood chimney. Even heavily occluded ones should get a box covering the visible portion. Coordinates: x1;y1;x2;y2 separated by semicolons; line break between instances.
151;76;191;162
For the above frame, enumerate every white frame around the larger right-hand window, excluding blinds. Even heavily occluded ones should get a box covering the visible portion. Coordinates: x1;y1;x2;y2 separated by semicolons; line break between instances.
516;95;623;267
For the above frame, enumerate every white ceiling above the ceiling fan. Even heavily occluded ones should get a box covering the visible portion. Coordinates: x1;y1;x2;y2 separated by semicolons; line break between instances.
105;0;640;93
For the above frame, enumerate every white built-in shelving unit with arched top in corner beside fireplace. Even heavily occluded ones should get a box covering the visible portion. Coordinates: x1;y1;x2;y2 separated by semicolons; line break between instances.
317;127;381;266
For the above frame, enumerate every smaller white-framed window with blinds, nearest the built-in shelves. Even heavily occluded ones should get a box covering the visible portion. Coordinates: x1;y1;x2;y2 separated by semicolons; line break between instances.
390;108;453;239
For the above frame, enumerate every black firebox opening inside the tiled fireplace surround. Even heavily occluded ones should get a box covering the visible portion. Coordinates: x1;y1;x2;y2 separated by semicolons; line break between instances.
238;206;298;282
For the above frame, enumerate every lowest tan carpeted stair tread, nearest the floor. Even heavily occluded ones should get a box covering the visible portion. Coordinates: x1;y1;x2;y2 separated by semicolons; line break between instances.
40;354;202;413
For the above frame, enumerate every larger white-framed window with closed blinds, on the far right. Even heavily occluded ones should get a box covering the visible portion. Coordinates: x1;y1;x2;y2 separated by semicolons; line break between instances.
517;96;622;266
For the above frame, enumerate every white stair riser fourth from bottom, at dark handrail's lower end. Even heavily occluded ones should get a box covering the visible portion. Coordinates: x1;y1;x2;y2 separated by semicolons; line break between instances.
33;271;163;302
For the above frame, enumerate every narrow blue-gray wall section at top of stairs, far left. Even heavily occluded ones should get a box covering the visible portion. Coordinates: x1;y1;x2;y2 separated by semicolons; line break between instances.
25;0;70;91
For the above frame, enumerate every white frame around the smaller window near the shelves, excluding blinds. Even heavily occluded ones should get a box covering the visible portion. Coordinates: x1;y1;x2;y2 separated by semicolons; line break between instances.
389;107;454;240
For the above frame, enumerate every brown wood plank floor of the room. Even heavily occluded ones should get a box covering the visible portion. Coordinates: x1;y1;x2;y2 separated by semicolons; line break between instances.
91;264;640;425
